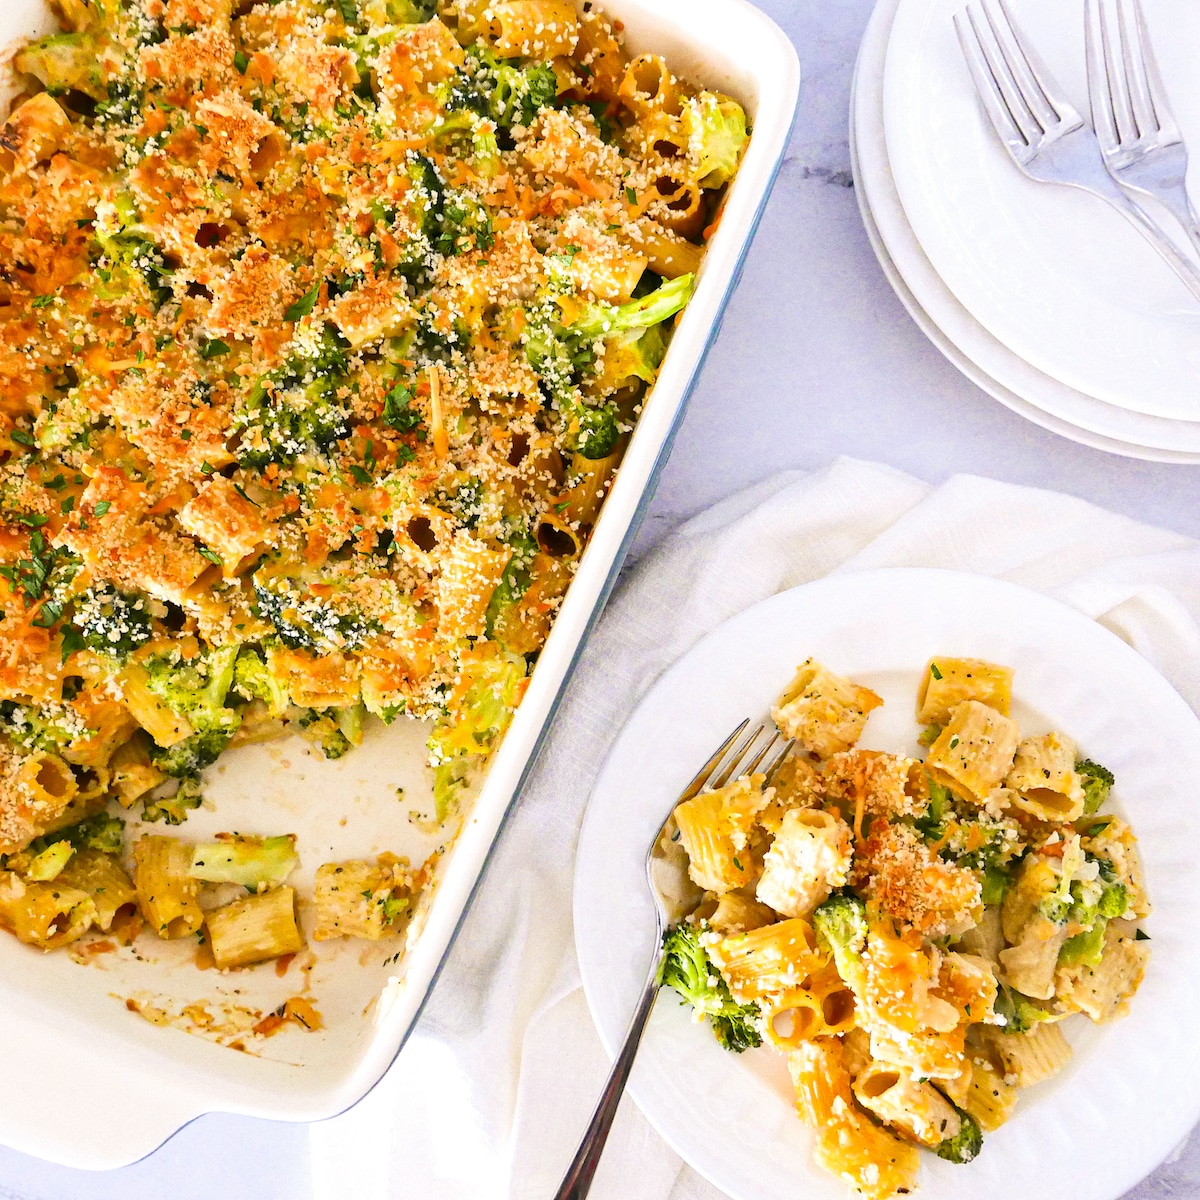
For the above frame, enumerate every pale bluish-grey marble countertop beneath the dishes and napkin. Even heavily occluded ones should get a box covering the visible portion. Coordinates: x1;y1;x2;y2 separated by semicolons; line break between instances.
0;0;1200;1200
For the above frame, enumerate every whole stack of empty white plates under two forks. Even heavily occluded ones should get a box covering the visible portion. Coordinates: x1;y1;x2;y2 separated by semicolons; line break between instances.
851;0;1200;462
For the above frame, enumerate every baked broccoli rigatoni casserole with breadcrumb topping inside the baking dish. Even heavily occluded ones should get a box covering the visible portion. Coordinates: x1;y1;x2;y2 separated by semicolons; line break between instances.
0;0;749;988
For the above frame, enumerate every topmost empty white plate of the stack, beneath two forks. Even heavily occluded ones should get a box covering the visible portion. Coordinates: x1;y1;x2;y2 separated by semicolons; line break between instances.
884;0;1200;420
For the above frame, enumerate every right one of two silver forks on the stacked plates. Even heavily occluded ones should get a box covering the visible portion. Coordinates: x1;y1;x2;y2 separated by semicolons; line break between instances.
1085;0;1200;258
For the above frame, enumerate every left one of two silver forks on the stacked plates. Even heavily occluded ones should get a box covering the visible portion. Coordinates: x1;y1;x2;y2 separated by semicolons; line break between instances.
954;0;1200;299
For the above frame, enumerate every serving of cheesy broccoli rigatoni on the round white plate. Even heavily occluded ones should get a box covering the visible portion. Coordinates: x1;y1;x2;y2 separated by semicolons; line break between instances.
660;656;1150;1200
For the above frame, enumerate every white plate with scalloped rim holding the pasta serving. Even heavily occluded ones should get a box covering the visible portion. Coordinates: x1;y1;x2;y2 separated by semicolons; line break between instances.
575;569;1200;1200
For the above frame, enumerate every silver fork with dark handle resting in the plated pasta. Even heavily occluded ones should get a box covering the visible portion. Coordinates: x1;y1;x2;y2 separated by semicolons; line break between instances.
554;719;796;1200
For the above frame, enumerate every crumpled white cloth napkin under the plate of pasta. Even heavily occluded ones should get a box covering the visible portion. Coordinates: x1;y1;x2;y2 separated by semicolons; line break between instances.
310;458;1200;1200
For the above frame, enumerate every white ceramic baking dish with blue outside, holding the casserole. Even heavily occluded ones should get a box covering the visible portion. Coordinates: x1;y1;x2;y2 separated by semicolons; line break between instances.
0;0;799;1168
